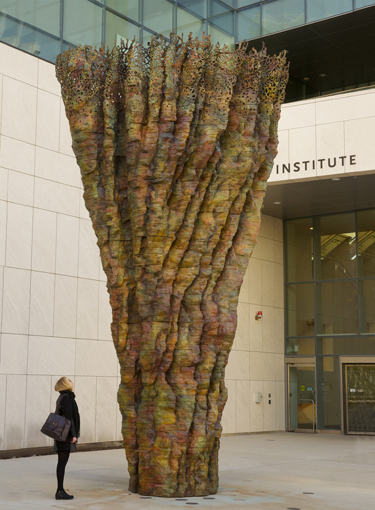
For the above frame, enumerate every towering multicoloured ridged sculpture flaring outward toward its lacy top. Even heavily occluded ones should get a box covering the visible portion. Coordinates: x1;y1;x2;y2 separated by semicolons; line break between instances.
56;34;288;497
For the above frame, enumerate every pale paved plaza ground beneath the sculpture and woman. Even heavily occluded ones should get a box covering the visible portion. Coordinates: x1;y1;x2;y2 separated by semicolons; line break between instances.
0;433;375;510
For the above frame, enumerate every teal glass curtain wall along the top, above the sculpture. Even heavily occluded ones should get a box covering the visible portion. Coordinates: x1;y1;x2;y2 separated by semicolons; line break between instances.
0;0;375;62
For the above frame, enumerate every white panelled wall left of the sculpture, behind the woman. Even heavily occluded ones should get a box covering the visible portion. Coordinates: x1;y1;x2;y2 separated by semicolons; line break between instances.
0;44;121;450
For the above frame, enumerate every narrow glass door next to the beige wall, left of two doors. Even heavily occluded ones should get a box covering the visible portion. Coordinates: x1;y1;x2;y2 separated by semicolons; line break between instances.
288;361;316;433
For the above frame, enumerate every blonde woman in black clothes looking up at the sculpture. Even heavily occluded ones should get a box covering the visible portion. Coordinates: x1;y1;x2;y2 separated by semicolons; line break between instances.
54;377;80;499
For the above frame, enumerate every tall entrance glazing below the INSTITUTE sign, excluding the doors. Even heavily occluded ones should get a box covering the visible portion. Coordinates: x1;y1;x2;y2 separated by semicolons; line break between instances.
284;209;375;429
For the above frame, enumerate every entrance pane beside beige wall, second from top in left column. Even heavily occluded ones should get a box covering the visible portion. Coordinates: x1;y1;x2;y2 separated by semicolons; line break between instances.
287;283;315;337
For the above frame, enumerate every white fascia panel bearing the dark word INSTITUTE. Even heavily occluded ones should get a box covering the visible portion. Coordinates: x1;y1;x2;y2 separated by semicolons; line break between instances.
270;88;375;184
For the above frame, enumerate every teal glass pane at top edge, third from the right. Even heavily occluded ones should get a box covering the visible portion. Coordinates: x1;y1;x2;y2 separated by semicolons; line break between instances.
262;0;305;35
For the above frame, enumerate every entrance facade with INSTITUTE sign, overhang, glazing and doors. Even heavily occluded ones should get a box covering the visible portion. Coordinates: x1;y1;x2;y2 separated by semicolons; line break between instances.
272;88;375;433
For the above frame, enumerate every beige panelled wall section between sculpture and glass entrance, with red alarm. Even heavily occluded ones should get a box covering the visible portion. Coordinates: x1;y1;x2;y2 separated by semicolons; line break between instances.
223;216;285;434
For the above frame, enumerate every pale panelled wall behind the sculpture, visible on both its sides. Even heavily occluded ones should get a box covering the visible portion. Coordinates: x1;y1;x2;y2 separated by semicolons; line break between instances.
0;43;284;450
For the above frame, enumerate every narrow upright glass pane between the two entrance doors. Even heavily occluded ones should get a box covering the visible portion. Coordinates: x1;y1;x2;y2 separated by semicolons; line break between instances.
316;356;340;430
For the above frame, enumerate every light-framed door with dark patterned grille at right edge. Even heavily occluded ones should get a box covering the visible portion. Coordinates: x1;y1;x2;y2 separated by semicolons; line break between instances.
344;363;375;435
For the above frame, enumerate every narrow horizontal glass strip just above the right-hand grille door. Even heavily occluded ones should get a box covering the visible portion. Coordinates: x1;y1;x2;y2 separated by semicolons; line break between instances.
317;336;375;356
